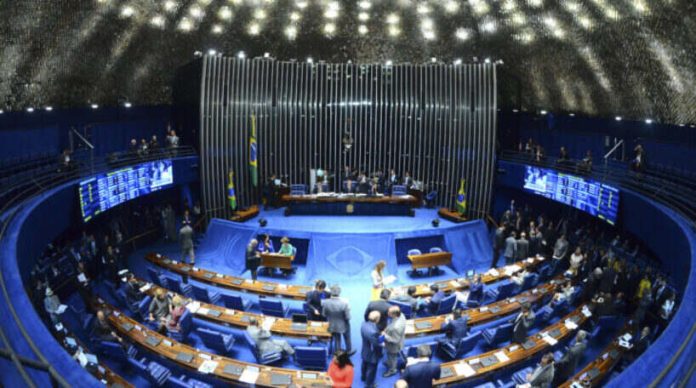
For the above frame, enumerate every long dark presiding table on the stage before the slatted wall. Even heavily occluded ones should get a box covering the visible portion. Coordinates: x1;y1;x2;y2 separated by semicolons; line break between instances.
282;193;419;216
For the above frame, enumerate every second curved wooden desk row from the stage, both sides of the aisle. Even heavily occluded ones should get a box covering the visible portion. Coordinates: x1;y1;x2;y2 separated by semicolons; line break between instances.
135;279;559;341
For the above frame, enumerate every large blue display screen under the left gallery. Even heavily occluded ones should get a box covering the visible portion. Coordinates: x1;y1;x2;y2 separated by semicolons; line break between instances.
79;159;174;222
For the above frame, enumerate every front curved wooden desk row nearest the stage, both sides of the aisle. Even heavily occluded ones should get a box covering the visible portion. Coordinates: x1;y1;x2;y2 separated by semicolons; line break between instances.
145;253;544;300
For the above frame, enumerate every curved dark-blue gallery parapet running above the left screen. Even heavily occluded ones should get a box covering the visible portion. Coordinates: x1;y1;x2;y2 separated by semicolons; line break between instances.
0;147;196;387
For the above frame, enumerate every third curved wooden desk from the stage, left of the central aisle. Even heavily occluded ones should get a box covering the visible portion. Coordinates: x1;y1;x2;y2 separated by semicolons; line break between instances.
103;304;332;387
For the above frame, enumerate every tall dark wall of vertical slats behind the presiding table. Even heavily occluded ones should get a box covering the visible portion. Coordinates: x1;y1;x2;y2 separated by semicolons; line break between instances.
200;56;497;218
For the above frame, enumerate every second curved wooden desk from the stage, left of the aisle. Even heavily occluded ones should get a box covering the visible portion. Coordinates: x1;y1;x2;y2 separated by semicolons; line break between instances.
139;279;331;341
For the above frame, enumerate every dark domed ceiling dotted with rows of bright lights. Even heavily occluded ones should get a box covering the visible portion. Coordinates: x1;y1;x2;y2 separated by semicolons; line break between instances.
0;0;696;124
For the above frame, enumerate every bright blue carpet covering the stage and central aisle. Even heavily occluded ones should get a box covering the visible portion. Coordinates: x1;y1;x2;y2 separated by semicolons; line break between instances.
114;210;613;387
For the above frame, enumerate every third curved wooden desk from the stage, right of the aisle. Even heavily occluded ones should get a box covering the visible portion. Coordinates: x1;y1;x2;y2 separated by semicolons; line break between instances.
433;305;588;386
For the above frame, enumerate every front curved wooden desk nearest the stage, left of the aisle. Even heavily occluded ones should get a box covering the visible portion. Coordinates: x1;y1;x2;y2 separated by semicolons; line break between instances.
145;253;312;300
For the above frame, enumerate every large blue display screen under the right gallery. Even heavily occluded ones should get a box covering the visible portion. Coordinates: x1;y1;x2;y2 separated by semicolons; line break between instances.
524;166;619;225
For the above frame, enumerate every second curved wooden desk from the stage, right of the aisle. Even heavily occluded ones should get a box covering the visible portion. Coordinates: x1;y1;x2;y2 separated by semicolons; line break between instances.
406;279;559;337
